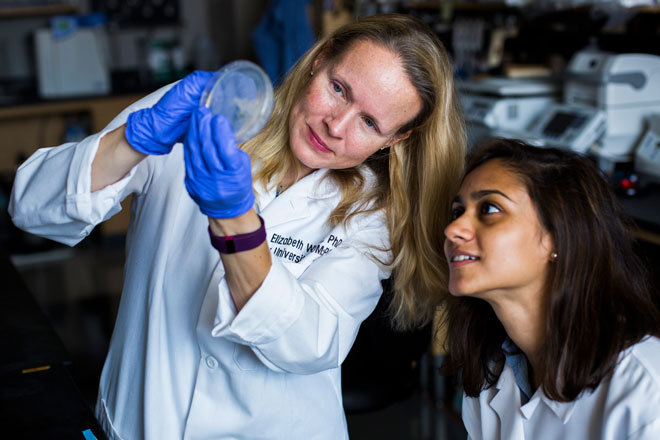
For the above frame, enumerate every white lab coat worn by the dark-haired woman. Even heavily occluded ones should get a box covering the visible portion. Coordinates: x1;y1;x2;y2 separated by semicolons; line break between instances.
463;337;660;440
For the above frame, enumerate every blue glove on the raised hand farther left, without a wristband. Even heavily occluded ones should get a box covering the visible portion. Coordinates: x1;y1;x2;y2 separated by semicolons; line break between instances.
125;70;213;154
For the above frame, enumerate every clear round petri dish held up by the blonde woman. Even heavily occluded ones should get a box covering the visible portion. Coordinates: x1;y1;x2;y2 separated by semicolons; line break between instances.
200;60;273;144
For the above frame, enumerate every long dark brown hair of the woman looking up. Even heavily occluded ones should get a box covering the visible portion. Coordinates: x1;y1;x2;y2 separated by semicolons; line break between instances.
443;138;660;401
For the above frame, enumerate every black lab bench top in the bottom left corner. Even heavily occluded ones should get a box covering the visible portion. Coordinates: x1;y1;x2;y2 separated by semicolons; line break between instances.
0;250;106;440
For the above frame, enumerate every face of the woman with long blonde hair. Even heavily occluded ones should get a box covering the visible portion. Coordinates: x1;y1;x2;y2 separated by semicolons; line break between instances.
289;42;422;176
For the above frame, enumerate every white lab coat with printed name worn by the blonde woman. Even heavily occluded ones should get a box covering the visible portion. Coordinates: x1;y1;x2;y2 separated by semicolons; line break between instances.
10;90;389;440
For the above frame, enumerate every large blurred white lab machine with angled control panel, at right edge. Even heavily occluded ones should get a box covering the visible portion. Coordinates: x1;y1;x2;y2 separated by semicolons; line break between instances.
526;50;660;162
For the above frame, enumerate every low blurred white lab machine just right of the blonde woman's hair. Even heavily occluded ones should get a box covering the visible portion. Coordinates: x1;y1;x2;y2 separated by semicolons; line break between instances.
457;77;560;147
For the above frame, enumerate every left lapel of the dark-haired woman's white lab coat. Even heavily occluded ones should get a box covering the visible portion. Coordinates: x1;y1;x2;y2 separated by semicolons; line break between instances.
489;364;525;440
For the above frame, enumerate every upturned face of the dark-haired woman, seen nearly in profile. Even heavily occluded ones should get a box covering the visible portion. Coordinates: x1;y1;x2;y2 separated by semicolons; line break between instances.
445;159;553;301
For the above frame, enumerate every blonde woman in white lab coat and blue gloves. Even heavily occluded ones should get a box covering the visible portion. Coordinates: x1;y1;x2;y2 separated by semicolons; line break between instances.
10;15;464;440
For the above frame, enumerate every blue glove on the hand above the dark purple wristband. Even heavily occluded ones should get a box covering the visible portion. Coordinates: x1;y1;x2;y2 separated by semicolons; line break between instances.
183;107;254;218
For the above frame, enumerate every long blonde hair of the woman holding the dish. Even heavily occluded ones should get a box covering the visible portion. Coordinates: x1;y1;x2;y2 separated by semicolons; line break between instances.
243;14;465;328
